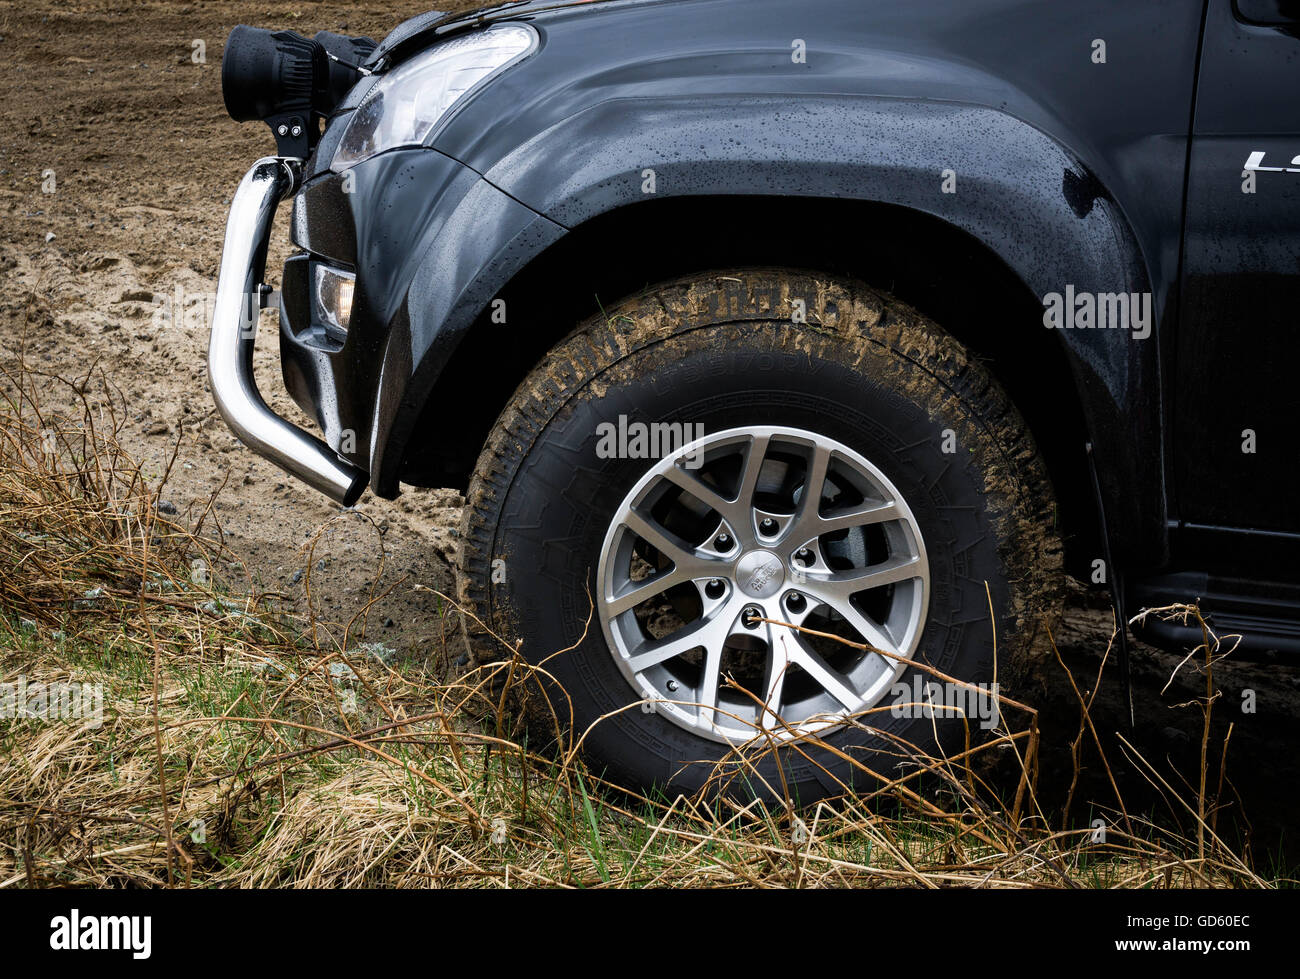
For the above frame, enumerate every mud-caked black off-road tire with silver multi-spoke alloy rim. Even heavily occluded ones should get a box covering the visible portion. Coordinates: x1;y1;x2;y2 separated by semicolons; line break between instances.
459;269;1061;803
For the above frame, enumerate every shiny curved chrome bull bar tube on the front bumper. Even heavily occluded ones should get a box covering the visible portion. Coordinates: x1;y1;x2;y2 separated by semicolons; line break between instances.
208;156;369;507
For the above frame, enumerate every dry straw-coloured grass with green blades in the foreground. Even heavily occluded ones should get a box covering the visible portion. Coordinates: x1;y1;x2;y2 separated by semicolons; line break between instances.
0;356;1277;888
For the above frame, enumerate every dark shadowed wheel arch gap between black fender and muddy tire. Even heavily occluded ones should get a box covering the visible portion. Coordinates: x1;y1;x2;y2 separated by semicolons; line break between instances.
400;195;1100;571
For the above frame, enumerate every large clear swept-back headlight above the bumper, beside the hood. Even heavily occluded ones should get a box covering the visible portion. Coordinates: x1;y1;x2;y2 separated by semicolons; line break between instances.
330;23;537;173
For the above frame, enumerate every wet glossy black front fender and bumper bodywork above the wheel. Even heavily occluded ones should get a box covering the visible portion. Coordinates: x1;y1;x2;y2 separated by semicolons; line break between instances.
283;0;1300;585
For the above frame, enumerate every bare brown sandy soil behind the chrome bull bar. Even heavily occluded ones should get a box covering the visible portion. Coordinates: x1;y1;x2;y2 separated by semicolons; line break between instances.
0;0;483;665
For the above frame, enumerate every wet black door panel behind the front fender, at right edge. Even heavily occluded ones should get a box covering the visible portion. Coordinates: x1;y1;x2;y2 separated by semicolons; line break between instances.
1170;0;1300;530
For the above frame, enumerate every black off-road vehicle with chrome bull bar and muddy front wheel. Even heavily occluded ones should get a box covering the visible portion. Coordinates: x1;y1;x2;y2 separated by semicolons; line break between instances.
209;0;1300;800
